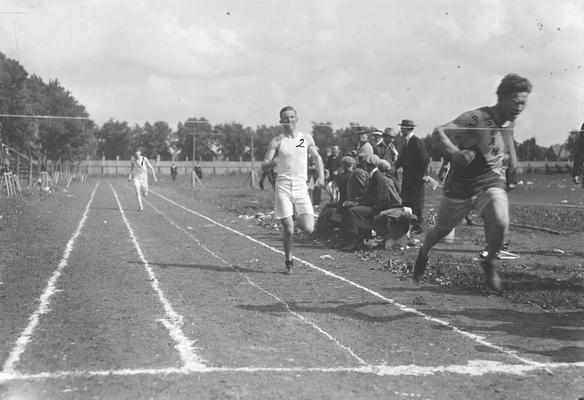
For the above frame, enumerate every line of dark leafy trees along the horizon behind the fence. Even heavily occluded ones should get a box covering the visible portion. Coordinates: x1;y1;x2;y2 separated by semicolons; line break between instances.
0;52;578;161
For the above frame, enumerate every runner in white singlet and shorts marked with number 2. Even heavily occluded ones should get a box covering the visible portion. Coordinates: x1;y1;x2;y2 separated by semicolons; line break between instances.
262;106;324;274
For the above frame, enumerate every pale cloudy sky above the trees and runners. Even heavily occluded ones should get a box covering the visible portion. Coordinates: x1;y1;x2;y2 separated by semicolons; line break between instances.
0;0;584;145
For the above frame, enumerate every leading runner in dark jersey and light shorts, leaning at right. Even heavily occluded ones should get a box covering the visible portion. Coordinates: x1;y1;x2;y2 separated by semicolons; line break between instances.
413;74;532;291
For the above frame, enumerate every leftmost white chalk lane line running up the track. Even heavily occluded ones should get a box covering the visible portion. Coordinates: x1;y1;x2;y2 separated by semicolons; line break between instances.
3;181;99;373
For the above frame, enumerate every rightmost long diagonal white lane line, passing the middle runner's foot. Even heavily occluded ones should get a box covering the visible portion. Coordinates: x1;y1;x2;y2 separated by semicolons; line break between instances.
151;191;542;366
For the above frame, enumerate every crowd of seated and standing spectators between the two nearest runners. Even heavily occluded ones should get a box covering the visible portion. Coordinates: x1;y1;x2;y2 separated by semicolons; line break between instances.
260;120;429;251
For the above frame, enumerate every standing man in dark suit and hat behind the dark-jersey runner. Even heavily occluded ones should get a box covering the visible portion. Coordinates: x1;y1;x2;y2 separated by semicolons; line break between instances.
395;119;430;234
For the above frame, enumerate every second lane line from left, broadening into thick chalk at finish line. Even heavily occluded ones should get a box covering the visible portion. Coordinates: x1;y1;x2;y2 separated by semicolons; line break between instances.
109;183;207;371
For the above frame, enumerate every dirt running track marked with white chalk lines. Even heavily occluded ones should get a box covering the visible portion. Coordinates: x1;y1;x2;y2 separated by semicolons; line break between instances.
0;180;584;400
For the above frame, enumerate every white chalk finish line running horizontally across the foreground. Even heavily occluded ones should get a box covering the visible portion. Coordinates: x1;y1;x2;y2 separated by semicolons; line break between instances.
0;360;584;384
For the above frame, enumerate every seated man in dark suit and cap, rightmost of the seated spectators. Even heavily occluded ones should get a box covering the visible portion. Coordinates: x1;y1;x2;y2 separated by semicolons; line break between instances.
342;155;399;251
